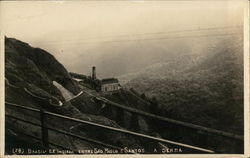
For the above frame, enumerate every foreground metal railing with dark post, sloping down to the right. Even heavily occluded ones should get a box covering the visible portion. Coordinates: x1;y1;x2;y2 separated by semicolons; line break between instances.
6;102;214;153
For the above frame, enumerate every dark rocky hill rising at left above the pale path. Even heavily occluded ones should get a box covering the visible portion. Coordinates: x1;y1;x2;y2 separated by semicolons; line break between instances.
5;38;80;100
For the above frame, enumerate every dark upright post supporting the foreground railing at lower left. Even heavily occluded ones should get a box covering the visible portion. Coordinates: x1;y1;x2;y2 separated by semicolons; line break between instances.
40;110;49;148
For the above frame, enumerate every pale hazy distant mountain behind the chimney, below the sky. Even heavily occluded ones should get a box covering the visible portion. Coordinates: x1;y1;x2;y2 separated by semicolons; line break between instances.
61;35;230;78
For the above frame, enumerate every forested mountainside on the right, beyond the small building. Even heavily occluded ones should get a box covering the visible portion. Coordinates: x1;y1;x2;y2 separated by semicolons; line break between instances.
119;36;244;134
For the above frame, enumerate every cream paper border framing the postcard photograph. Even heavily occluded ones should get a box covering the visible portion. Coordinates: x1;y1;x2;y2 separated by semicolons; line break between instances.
0;0;250;158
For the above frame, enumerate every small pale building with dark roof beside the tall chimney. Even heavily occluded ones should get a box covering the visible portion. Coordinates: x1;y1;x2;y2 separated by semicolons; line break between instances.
101;78;120;92
